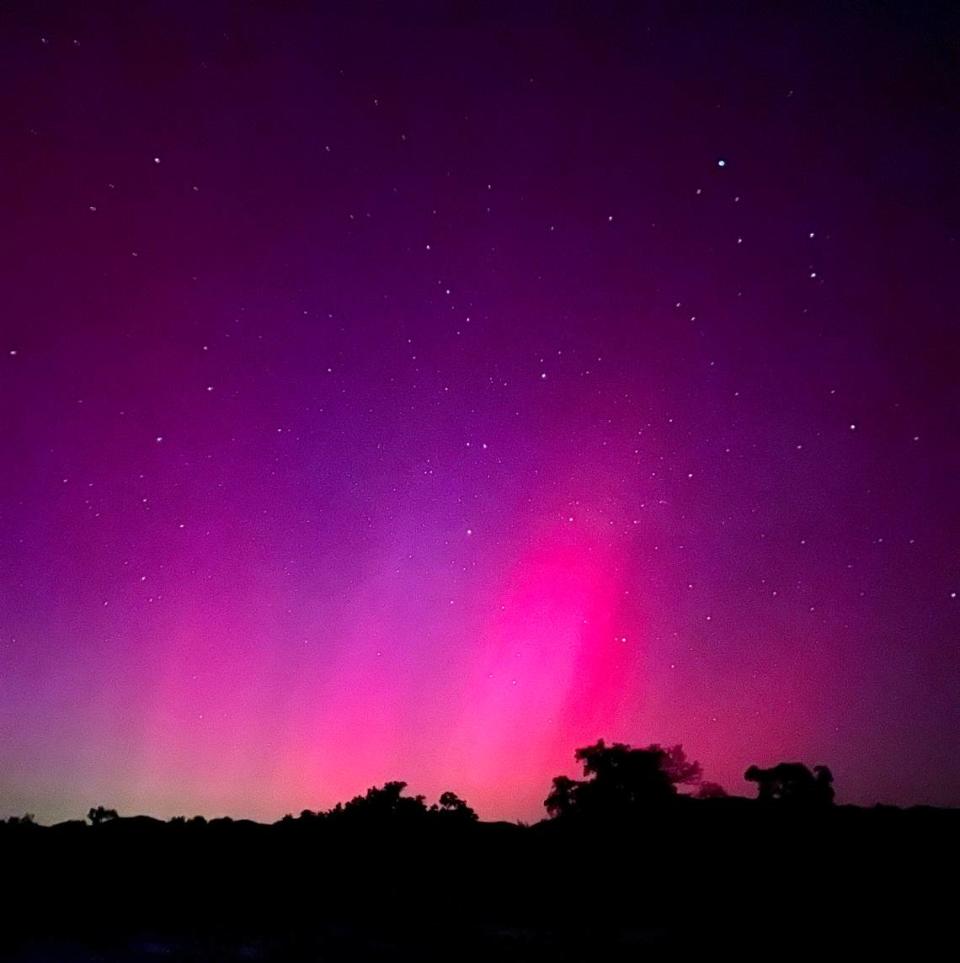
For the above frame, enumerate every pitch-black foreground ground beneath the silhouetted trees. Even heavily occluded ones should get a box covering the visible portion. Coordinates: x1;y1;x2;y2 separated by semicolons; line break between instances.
0;799;960;963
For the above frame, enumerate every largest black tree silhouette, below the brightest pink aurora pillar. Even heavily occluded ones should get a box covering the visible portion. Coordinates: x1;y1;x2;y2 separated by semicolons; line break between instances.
544;739;702;817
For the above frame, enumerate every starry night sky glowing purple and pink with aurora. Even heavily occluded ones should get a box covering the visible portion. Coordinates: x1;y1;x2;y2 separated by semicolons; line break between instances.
0;0;960;821
